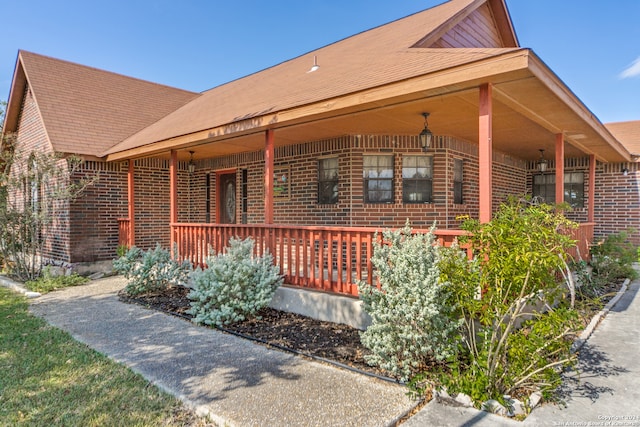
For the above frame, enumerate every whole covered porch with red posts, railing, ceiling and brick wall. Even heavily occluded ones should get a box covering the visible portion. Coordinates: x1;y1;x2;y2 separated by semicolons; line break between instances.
108;49;628;295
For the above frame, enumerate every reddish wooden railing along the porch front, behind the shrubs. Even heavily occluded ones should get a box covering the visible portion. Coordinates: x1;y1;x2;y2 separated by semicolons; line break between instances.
171;224;472;296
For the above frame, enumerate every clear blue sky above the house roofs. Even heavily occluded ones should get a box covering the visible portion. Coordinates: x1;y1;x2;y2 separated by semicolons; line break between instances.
0;0;640;123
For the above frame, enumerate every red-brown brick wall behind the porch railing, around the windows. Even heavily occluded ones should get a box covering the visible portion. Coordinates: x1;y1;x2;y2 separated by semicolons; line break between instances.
185;135;526;232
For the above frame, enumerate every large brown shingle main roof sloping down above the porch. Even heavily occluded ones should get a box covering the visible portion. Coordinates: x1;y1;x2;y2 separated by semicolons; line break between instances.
107;0;518;154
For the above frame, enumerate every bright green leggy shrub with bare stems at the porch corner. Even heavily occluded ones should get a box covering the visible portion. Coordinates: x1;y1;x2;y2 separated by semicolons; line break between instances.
441;199;578;403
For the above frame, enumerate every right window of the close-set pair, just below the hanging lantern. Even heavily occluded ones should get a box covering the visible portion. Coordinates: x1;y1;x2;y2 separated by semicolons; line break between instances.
402;156;433;203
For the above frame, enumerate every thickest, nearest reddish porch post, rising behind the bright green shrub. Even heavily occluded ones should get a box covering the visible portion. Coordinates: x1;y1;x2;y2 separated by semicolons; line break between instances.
478;83;493;222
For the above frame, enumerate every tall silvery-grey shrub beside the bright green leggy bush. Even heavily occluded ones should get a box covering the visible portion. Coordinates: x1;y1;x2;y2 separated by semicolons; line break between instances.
358;224;459;381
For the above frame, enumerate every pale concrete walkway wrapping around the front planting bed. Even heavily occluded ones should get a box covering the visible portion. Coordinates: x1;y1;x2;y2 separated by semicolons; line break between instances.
15;272;640;427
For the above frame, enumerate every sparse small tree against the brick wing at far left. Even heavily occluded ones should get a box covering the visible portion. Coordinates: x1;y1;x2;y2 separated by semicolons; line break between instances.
0;146;97;281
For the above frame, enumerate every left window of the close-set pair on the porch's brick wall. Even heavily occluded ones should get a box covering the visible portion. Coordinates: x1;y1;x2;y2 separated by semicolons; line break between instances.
362;156;393;203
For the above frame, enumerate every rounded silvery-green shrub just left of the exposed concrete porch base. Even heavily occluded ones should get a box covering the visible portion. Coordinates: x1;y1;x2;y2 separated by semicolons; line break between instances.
188;238;283;326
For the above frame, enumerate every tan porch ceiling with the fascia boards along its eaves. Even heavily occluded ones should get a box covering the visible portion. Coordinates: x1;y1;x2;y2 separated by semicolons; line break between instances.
108;50;630;162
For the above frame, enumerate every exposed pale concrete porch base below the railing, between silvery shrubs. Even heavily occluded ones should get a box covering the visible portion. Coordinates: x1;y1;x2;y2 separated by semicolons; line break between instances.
269;286;371;330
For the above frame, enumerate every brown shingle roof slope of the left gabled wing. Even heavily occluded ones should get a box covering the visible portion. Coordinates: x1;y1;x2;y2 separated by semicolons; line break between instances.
18;51;198;156
